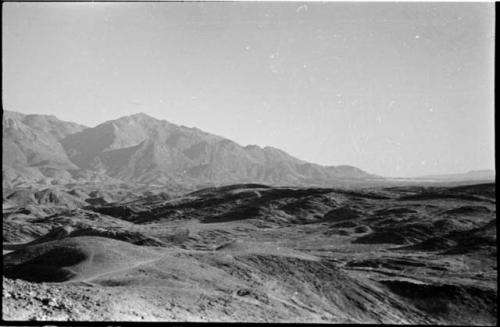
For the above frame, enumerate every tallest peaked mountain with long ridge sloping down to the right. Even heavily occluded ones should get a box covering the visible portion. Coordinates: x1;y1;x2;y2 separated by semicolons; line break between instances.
61;114;372;185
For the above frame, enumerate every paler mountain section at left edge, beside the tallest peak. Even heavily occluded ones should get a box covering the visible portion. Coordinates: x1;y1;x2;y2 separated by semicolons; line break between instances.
2;111;116;187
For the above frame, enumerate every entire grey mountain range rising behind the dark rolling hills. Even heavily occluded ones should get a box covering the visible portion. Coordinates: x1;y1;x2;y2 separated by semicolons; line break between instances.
2;112;377;186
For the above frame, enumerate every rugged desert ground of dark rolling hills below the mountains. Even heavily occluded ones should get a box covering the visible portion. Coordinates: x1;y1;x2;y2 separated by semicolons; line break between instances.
2;183;497;325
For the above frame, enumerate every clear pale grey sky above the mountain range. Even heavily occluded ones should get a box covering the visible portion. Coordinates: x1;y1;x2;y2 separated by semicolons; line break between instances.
2;2;495;177
